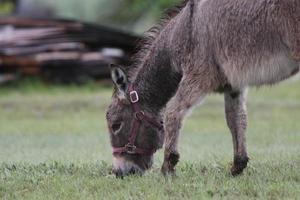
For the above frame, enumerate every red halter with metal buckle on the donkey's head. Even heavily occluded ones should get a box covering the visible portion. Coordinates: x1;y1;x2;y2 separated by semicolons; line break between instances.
113;84;163;155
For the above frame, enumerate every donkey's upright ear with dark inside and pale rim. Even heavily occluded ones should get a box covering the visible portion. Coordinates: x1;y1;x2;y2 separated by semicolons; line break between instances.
110;64;128;93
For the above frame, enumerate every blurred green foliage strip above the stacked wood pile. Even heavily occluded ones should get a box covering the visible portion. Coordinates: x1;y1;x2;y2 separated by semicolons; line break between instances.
0;0;180;33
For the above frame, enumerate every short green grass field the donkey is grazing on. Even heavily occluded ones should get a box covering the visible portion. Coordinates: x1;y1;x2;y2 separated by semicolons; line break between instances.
0;81;300;200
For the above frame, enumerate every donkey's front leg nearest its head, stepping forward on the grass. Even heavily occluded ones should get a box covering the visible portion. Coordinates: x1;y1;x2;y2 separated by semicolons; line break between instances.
162;77;207;175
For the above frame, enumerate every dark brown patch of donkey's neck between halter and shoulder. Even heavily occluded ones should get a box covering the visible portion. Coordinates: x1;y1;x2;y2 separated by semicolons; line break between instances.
134;47;182;112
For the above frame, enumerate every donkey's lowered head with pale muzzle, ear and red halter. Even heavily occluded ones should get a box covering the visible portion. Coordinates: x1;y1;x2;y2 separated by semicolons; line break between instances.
106;65;163;177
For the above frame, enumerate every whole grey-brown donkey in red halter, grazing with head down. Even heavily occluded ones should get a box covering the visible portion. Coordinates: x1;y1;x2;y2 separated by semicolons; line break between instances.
106;0;300;176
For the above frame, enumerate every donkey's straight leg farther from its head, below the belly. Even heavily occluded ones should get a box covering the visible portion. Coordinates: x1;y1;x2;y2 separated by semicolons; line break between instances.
225;90;249;176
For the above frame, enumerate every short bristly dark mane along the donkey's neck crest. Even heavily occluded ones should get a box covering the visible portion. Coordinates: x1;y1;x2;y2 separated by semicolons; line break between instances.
127;0;190;77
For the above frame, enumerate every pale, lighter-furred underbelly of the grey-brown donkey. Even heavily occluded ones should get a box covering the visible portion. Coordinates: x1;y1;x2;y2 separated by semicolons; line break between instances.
224;54;300;89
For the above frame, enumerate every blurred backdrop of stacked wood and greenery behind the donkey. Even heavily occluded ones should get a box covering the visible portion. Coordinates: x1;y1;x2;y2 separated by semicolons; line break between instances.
0;0;179;84
